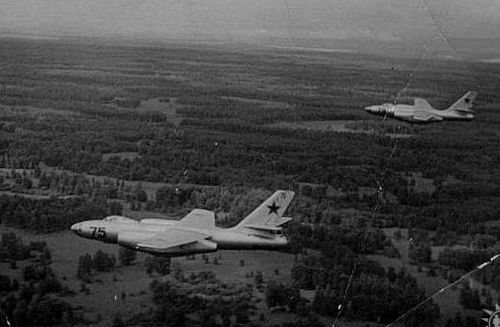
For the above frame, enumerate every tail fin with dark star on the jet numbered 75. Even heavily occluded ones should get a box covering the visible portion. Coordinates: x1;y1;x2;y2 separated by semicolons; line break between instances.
235;190;295;228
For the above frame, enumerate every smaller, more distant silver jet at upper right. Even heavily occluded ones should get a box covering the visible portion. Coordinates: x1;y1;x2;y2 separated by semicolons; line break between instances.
365;91;477;123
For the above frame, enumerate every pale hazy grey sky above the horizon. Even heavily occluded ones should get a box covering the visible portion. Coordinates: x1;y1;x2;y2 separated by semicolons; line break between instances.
0;0;500;40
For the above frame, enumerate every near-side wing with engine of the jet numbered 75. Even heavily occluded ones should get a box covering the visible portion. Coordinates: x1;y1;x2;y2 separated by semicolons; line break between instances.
136;228;211;254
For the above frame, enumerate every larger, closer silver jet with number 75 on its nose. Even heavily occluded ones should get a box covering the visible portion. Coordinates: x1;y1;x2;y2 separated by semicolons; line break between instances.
71;191;294;257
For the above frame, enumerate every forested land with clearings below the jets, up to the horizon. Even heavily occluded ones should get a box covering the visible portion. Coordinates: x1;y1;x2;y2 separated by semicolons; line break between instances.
0;36;500;327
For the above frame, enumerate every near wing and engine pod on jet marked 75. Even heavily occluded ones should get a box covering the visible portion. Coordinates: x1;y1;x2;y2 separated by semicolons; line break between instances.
135;228;217;256
